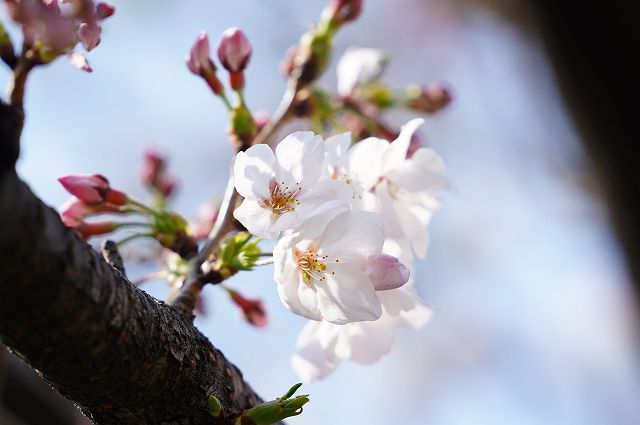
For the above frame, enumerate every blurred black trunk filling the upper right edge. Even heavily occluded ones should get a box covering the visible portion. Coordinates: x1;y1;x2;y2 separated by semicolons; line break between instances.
529;0;640;306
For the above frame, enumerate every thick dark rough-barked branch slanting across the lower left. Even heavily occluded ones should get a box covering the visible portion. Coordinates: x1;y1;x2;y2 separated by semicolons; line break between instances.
0;106;259;425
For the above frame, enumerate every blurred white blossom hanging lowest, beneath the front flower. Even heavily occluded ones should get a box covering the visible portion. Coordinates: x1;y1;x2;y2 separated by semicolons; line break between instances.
291;285;432;382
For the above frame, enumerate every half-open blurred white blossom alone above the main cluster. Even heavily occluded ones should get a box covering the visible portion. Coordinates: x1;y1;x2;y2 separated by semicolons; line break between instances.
336;47;389;96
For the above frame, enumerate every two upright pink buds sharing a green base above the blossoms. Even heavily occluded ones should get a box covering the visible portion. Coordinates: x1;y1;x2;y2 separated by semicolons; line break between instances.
187;27;257;150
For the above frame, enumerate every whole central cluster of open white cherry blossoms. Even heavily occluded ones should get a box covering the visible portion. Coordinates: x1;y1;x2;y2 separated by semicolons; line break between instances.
234;119;445;380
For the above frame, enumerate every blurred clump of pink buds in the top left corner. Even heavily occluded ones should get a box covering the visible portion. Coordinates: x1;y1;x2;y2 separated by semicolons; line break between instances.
0;0;115;72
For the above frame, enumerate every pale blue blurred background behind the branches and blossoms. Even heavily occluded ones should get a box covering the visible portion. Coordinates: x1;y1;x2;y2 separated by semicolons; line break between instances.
0;0;640;425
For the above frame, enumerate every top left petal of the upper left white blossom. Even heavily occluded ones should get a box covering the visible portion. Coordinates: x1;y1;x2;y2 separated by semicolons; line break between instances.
233;145;275;201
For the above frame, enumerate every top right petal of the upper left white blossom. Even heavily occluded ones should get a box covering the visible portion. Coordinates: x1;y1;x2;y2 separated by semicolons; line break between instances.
276;131;324;189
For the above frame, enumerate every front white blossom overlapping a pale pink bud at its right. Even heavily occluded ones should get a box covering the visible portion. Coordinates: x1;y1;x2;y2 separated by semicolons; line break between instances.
273;202;384;324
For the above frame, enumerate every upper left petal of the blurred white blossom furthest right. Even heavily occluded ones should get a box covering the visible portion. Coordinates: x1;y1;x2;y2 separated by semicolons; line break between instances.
349;137;389;190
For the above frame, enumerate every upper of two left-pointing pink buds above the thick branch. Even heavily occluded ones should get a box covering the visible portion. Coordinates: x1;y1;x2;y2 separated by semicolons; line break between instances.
58;174;128;206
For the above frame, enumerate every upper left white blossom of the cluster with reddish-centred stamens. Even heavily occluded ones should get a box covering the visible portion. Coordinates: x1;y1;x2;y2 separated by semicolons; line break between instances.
234;131;352;238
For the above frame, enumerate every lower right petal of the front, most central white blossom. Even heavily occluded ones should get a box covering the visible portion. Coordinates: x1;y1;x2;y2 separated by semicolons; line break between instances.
314;264;382;325
